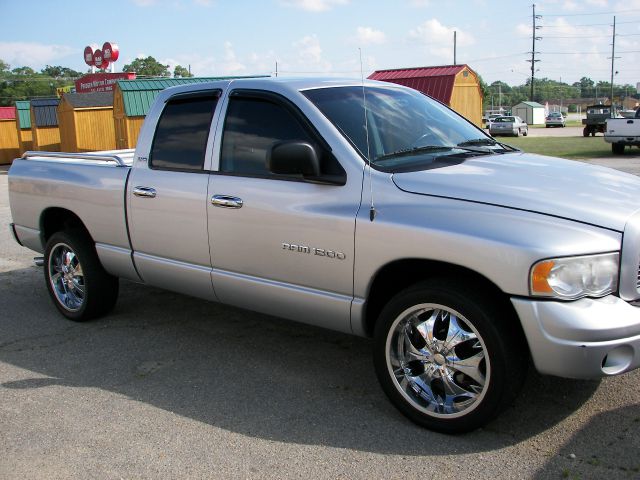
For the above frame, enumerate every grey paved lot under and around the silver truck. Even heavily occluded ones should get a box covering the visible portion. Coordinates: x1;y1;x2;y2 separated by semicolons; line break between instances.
0;152;640;479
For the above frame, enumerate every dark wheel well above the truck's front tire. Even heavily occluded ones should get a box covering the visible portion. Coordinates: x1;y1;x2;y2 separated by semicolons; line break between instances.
364;259;524;338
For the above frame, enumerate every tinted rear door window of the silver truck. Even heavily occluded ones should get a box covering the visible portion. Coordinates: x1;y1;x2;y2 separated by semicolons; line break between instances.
150;95;218;170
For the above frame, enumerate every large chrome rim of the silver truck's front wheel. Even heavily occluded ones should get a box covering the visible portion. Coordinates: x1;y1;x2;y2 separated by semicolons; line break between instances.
386;303;491;418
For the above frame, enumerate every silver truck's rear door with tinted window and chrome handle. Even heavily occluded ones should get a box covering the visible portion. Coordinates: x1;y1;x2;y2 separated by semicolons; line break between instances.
127;91;219;300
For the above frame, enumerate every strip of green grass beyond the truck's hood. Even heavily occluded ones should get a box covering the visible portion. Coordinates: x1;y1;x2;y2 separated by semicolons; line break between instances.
496;136;612;160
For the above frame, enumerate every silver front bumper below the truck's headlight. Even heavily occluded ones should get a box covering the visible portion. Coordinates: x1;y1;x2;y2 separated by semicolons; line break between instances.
511;295;640;378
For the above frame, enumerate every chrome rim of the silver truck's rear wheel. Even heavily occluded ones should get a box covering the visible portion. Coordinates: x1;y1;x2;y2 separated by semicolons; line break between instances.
47;243;85;312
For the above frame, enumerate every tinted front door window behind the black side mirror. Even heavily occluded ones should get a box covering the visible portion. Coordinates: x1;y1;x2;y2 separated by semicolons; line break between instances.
220;97;314;175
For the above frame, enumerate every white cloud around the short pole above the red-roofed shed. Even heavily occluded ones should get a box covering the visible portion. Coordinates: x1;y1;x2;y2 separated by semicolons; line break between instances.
409;18;476;64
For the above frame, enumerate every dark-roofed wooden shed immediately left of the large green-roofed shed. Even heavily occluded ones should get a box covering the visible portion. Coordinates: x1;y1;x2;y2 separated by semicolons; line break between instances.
58;92;116;152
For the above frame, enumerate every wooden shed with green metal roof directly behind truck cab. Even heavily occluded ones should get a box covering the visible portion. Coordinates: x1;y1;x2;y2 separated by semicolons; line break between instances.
113;77;268;149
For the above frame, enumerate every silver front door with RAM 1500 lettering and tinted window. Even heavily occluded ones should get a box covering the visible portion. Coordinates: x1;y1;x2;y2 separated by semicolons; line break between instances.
207;90;362;332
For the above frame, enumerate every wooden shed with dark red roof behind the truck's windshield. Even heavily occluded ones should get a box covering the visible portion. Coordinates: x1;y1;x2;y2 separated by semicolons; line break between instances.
369;65;482;127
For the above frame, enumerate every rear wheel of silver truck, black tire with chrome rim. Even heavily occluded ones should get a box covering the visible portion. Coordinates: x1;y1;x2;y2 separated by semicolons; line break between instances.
44;230;119;322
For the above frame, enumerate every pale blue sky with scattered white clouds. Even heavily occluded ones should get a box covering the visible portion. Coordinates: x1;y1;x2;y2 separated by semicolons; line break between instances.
0;0;640;85
